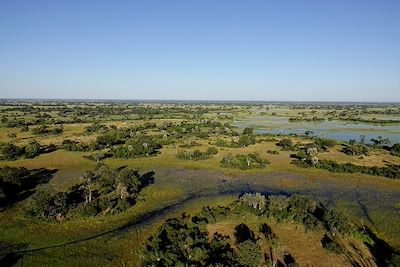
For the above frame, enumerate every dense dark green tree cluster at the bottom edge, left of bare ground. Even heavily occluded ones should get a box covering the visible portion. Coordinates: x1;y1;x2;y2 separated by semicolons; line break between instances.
142;214;263;266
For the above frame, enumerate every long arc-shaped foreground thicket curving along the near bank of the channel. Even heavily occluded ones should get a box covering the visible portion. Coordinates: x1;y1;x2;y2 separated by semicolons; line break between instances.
141;193;378;266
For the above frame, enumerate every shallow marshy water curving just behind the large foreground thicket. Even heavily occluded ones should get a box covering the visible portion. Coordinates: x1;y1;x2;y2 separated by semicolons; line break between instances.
156;169;400;246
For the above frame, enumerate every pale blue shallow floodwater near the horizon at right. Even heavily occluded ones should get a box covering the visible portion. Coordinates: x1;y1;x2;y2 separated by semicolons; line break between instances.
232;115;400;144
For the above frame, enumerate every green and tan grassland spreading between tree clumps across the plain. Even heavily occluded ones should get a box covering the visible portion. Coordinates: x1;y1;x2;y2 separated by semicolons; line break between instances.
0;103;400;266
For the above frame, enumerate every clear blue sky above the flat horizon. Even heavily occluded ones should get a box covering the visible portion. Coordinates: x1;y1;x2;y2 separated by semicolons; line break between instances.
0;0;400;102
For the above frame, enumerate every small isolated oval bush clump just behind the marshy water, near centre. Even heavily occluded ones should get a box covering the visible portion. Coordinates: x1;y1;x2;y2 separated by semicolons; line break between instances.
221;154;269;170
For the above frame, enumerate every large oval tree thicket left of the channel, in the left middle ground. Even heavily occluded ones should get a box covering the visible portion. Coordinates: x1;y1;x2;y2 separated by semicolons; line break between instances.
26;165;154;220
